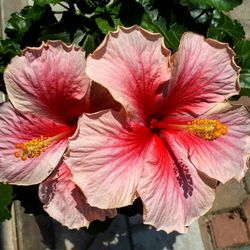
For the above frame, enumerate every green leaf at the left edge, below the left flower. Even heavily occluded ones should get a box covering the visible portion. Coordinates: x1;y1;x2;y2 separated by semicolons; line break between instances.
0;183;13;222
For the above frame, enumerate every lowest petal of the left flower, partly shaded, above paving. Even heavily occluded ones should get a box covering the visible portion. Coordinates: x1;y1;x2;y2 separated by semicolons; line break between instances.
39;163;116;229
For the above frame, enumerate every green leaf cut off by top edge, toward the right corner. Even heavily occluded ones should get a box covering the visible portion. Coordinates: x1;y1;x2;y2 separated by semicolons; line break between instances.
180;0;242;11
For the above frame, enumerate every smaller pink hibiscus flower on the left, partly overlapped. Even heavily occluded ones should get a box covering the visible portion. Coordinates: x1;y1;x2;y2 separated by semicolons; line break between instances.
0;41;116;228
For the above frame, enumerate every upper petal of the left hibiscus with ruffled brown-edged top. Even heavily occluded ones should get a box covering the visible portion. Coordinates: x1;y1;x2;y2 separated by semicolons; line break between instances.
4;41;89;122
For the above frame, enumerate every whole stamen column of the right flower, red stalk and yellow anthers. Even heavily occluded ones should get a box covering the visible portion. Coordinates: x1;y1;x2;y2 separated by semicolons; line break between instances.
150;119;228;141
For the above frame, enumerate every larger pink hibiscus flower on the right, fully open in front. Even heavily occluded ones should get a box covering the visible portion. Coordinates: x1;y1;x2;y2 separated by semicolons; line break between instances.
65;26;250;232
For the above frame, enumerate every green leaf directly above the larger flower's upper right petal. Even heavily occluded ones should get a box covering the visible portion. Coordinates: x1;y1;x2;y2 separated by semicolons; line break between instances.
207;11;245;44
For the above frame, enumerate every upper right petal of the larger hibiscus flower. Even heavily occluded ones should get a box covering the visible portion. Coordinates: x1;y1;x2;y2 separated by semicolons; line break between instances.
166;32;239;115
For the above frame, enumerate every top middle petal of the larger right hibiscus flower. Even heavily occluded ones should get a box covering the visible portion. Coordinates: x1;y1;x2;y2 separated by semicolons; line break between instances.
86;26;170;122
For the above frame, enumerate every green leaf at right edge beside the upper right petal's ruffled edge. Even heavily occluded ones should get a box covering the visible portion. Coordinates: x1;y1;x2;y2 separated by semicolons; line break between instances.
234;40;250;69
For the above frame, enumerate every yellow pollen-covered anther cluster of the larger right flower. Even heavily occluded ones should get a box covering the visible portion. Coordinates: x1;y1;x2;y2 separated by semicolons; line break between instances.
187;119;228;141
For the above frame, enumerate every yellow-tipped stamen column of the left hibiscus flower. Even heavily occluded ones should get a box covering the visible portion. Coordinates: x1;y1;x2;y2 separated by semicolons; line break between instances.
14;130;72;161
